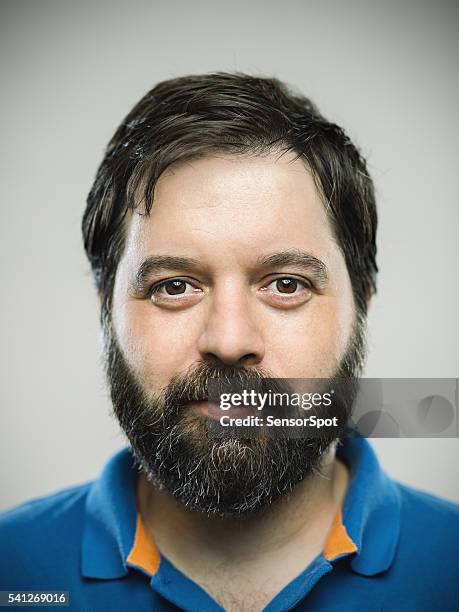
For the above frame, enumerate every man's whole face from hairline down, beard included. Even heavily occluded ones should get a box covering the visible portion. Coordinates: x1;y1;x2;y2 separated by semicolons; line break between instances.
107;155;362;513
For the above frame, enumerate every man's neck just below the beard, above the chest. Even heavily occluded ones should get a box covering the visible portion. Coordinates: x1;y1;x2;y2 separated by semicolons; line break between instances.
137;446;347;568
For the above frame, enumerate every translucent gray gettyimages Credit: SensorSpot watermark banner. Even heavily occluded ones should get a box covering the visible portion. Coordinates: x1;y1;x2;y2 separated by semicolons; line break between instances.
208;378;459;438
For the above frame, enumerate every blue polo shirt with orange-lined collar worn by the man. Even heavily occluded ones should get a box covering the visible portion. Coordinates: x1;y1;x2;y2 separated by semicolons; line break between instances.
0;437;459;612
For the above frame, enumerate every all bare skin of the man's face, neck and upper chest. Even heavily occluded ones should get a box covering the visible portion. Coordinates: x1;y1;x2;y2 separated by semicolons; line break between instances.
113;154;355;610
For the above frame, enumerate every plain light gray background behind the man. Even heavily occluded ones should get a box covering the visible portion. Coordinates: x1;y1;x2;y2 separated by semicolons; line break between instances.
0;0;459;508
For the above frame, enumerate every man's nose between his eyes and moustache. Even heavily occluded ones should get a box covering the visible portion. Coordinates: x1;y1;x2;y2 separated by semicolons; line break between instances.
198;289;265;366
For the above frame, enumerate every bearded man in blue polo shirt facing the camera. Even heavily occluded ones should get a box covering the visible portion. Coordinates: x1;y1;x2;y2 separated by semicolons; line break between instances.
1;73;459;611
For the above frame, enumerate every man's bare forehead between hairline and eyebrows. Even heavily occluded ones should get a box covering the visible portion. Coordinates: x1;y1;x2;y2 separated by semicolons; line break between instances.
125;154;337;263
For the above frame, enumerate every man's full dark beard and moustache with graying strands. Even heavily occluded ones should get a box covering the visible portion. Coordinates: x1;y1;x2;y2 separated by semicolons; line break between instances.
104;315;366;518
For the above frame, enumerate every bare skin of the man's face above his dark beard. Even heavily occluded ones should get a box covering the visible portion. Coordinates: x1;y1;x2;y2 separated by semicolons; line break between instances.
113;155;355;392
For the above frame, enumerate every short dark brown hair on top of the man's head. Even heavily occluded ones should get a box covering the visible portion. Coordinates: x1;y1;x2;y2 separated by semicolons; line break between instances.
82;72;378;317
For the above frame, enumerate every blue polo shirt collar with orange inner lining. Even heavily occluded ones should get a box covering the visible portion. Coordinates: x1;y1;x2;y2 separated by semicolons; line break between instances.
81;437;400;580
